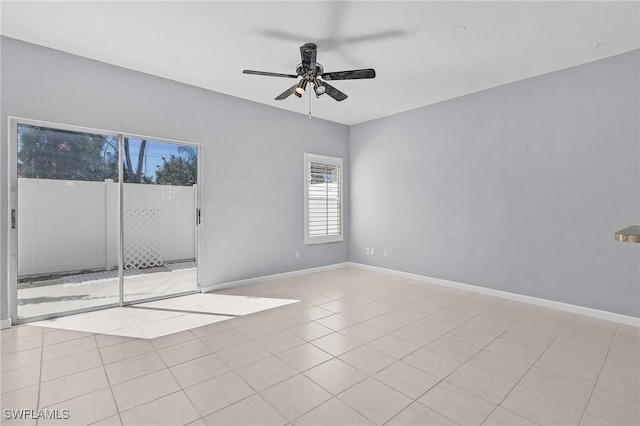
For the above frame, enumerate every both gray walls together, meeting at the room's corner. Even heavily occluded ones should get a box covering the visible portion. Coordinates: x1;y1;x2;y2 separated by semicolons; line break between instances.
0;38;640;319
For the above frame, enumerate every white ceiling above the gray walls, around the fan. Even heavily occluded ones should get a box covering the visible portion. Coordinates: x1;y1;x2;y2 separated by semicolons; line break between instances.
0;1;640;125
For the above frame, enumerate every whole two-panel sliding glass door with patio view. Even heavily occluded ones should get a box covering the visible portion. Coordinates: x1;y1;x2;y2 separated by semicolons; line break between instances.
11;121;199;321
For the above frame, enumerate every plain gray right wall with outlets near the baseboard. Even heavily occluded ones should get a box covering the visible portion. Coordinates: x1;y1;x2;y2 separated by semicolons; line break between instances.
350;50;640;317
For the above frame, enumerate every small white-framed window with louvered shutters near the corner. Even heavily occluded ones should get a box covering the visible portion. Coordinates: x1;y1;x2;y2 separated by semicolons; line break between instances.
304;154;343;244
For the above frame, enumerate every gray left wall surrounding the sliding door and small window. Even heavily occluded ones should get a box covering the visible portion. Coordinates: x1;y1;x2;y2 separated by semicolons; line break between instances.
0;38;349;319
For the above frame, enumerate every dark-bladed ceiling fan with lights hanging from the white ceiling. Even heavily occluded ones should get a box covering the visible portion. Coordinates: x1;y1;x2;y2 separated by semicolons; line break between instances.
242;43;376;102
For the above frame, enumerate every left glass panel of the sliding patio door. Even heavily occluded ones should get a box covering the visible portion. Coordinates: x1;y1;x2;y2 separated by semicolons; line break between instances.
13;124;119;318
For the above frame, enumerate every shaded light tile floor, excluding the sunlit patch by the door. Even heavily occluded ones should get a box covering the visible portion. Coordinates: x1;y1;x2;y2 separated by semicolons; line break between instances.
1;268;640;425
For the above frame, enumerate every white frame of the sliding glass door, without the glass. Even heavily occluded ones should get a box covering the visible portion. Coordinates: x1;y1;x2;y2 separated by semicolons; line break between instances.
6;116;204;325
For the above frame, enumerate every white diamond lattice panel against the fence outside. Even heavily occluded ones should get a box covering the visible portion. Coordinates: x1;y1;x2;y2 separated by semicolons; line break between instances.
124;209;162;269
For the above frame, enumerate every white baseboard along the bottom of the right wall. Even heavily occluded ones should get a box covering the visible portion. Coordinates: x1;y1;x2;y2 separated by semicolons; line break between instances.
349;262;640;327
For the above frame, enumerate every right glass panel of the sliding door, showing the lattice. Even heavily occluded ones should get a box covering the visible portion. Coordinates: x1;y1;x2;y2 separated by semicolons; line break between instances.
122;137;198;303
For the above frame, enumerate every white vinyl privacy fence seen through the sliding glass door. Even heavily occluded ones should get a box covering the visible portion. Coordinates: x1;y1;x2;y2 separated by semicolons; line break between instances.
17;178;196;276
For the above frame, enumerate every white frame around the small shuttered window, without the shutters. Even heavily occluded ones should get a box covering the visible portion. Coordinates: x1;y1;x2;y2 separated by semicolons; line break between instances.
304;152;344;245
